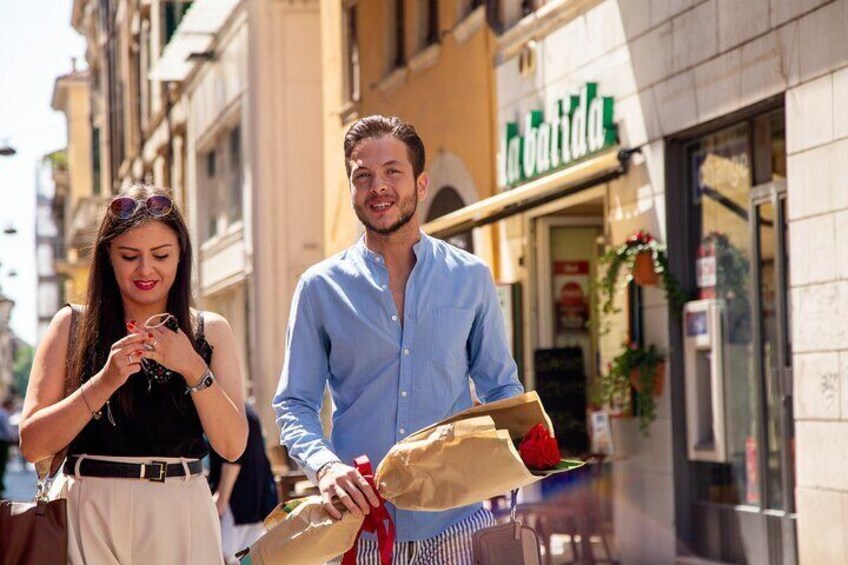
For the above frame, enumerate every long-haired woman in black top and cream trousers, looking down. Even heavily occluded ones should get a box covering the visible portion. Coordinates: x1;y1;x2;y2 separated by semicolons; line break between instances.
20;185;247;564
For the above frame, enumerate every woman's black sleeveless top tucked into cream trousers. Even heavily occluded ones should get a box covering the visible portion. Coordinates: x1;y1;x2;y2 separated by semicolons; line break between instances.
68;312;212;459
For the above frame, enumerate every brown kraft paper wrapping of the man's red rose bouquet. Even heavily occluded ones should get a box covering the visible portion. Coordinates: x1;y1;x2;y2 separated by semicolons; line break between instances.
242;392;583;565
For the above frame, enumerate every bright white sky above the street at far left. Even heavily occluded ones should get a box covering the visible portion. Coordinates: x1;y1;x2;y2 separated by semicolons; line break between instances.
0;0;86;345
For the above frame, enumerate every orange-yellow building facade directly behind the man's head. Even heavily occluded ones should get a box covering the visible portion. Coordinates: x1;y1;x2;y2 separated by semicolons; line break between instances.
321;0;497;261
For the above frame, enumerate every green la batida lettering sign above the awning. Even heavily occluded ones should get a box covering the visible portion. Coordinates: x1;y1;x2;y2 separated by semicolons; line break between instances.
499;82;616;187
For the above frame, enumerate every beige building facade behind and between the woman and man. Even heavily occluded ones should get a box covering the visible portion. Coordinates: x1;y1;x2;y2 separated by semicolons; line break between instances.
72;0;323;436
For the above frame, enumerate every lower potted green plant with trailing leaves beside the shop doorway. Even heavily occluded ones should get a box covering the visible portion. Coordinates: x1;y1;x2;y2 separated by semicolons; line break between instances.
598;343;665;435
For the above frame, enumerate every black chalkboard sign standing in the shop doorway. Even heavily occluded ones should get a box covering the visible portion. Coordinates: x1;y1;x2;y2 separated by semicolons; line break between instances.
533;347;589;456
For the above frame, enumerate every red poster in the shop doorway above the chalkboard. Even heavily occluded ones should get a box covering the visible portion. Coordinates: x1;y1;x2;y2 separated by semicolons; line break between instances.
553;261;589;334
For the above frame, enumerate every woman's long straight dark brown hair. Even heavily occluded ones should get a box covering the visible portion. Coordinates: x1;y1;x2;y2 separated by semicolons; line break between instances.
68;184;197;411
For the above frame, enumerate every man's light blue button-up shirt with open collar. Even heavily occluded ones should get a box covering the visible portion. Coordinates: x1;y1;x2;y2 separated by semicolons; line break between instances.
274;233;523;541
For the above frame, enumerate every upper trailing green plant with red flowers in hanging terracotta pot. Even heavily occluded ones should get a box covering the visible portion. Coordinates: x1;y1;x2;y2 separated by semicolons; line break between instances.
593;230;686;333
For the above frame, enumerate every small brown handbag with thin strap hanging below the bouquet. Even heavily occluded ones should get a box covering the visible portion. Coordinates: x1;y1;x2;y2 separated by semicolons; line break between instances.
471;489;542;565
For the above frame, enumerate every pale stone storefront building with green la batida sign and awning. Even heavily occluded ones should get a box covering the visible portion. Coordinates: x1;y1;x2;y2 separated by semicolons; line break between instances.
425;0;848;563
